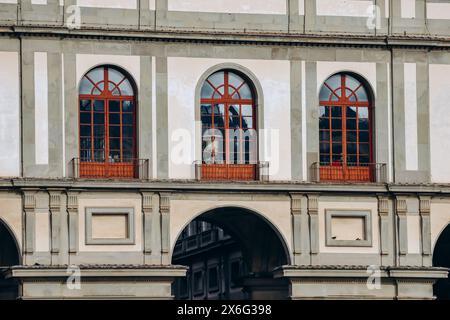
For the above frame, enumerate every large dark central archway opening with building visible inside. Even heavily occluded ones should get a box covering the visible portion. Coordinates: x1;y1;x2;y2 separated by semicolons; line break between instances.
172;208;289;300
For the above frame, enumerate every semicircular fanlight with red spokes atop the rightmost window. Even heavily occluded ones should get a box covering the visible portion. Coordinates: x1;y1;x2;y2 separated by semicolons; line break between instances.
319;73;369;103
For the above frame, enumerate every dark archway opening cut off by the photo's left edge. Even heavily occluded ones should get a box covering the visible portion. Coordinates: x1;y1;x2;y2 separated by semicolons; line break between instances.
0;220;20;300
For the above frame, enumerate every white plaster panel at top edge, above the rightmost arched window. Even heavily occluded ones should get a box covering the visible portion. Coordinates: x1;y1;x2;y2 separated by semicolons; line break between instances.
316;0;373;17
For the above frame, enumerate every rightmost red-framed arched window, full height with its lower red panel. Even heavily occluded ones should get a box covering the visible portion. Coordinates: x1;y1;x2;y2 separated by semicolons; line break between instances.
319;73;373;180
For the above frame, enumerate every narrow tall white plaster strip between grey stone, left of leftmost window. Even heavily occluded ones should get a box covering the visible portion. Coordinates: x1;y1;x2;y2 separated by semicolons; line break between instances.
34;52;48;165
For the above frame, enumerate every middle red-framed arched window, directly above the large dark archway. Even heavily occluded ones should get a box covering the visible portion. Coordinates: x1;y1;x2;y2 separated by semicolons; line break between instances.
201;70;257;180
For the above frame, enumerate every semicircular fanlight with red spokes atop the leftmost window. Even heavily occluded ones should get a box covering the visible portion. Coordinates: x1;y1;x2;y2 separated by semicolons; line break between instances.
80;66;134;96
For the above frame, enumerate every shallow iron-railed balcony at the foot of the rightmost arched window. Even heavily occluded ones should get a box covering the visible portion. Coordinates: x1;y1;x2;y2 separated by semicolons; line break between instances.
311;162;387;183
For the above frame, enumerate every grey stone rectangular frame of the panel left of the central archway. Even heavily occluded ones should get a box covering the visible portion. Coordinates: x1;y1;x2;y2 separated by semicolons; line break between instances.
85;207;135;245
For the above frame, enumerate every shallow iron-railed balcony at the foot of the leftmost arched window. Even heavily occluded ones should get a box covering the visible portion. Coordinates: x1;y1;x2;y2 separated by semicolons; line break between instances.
72;158;150;180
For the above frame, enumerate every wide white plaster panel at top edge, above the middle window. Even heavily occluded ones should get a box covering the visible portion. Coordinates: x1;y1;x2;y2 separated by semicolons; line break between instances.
168;0;287;14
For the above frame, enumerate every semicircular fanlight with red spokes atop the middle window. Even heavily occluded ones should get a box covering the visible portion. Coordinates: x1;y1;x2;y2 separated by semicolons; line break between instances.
201;70;253;100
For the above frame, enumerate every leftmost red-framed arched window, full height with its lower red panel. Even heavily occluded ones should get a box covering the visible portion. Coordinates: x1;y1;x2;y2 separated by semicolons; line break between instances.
79;66;137;178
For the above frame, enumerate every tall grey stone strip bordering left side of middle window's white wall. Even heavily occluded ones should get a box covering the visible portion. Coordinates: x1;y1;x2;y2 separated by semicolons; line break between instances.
155;57;169;179
